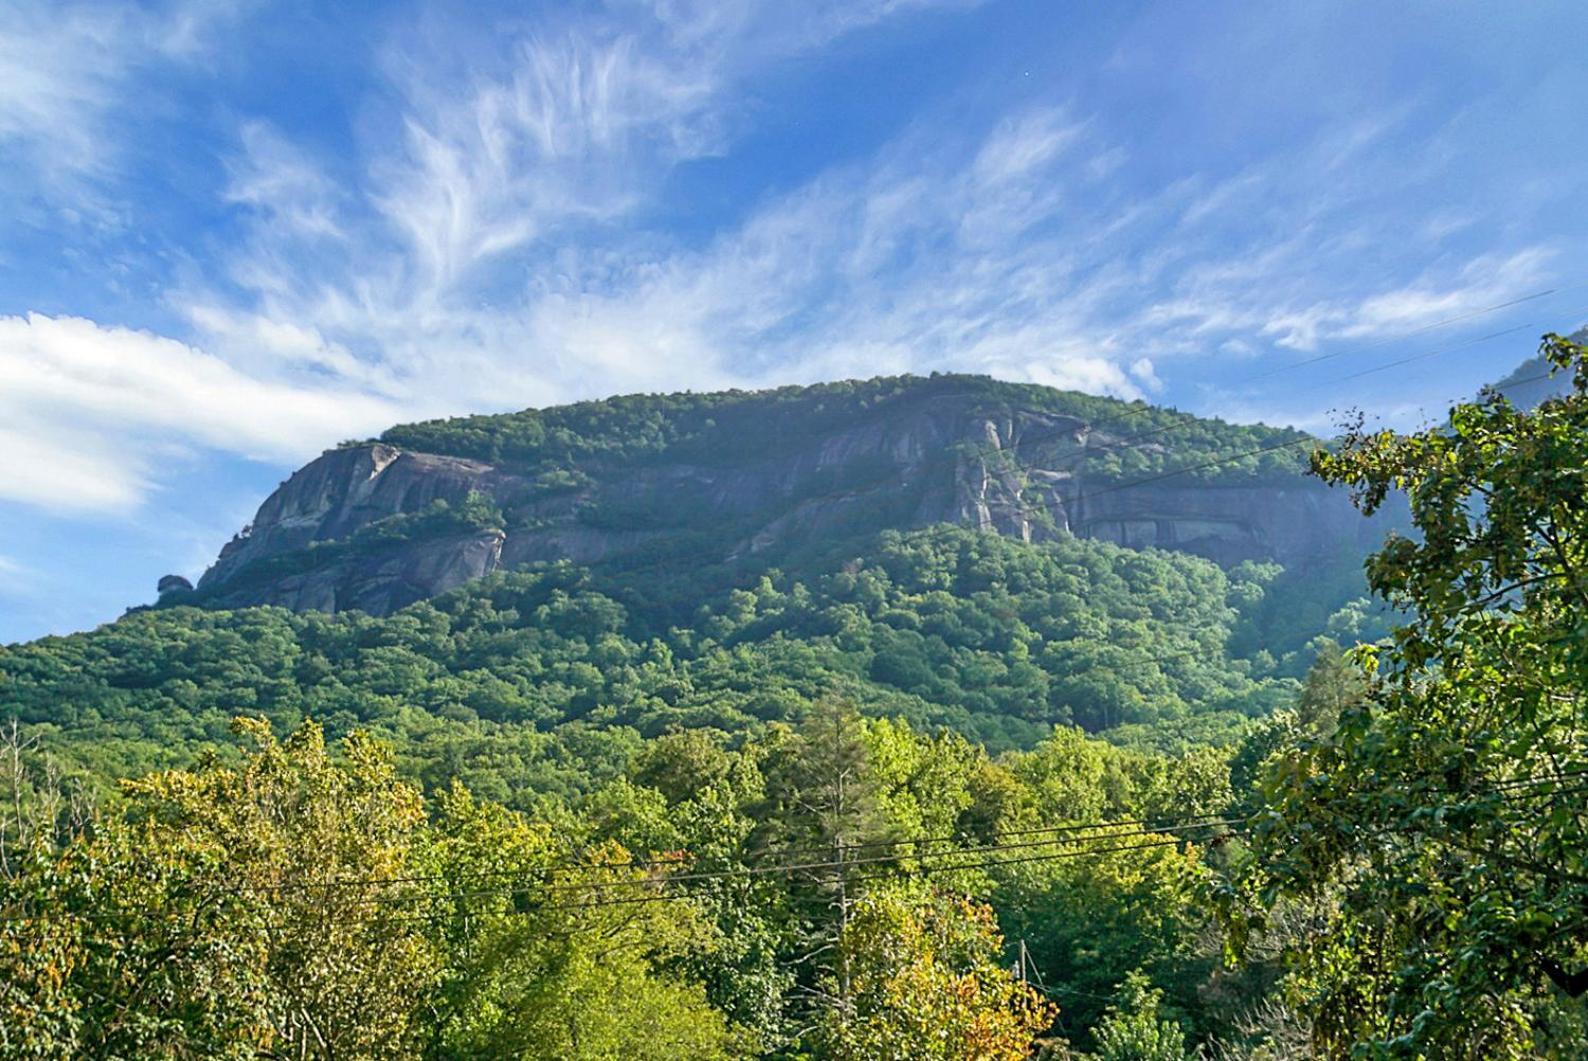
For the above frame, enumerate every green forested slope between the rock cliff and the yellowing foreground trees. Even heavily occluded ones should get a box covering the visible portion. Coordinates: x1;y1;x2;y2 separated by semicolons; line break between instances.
0;526;1372;807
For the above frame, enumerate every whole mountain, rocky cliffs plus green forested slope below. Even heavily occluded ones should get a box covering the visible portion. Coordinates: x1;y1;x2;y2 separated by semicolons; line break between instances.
0;376;1383;807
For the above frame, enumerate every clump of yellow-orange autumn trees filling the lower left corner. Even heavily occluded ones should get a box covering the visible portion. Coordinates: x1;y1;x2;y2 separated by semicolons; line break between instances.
0;720;437;1058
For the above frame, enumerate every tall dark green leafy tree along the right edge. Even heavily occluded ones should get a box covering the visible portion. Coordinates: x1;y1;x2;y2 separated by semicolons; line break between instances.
1237;335;1588;1058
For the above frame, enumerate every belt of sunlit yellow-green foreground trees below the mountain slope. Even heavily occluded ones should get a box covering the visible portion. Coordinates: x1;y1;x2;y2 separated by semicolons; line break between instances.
0;700;1229;1058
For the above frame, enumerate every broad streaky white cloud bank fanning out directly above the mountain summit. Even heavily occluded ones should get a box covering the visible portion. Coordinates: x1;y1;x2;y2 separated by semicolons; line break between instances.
187;70;1548;438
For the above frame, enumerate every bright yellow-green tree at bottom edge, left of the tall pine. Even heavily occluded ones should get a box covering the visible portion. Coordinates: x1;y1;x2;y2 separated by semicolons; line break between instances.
422;786;737;1061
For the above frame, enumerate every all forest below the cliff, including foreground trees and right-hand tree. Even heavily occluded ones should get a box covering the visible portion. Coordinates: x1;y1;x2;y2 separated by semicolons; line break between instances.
0;337;1588;1061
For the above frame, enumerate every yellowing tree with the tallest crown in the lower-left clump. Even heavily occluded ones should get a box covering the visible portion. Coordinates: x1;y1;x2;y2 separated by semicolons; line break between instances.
142;720;438;1058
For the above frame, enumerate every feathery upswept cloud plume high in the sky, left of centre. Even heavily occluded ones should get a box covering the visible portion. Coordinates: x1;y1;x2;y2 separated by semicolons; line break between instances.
373;35;713;297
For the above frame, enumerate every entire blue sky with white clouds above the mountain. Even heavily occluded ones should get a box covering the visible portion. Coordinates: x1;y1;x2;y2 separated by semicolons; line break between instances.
0;0;1588;640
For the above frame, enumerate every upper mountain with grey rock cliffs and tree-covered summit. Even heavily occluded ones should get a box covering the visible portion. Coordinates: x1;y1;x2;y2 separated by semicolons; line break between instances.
180;375;1375;615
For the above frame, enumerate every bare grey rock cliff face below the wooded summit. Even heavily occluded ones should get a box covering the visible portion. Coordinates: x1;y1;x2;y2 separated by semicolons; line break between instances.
185;382;1375;615
